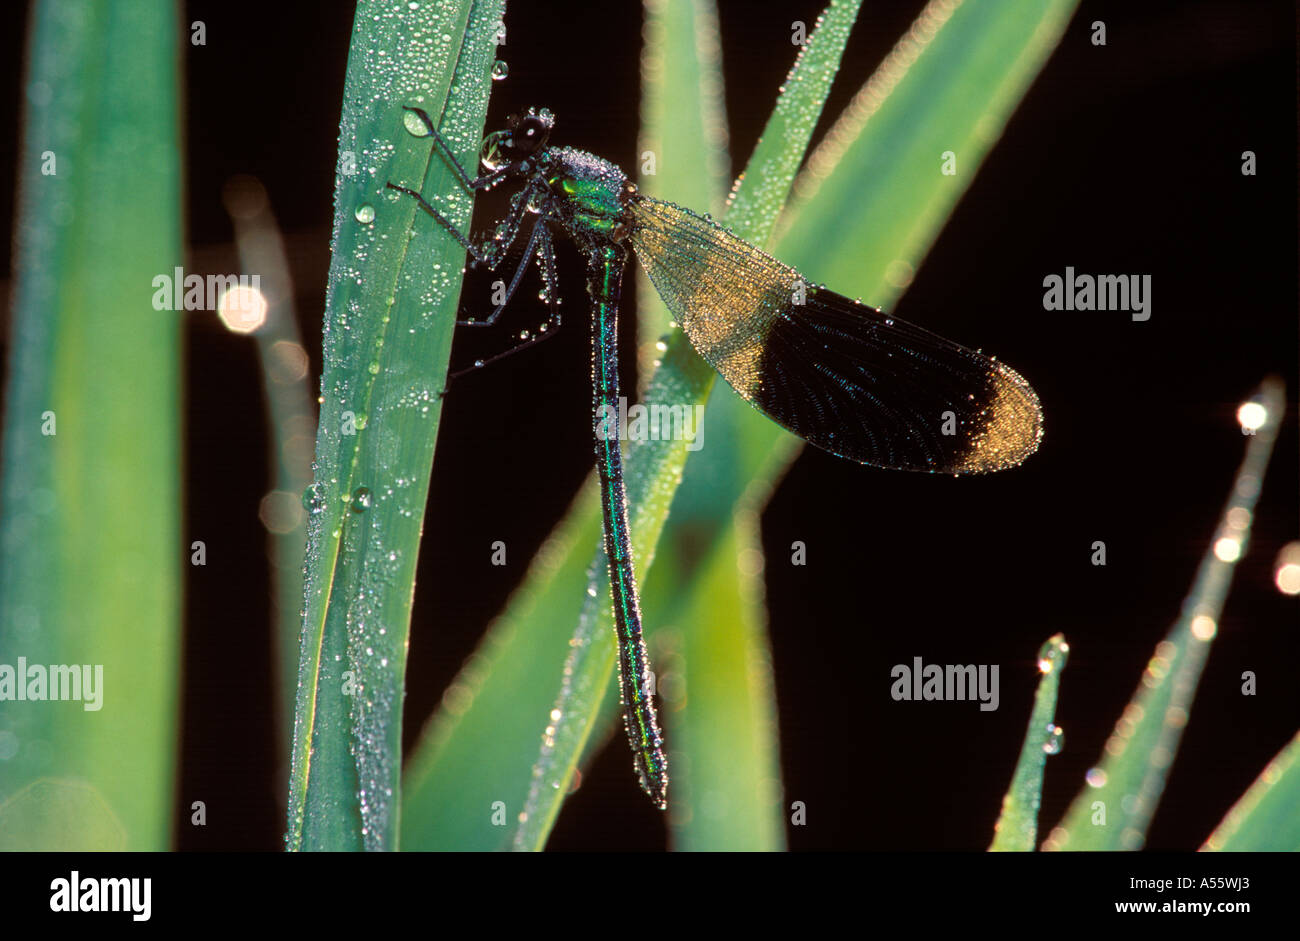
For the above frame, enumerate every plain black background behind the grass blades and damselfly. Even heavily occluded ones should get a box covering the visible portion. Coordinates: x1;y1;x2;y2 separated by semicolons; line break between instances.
0;0;1300;850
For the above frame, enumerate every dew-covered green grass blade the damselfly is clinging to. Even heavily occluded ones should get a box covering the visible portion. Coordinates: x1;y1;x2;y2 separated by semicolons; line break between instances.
287;0;502;850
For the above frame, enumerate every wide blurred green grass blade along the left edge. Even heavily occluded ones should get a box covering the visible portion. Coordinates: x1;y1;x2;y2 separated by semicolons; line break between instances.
0;0;184;850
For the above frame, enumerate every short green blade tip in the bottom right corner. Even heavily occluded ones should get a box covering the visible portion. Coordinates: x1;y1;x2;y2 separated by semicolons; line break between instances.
1201;733;1300;853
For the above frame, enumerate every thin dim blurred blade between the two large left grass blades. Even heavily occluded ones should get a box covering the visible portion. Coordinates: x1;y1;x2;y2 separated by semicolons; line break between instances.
222;177;316;769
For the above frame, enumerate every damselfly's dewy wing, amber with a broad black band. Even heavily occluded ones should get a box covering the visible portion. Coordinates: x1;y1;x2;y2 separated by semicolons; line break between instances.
631;198;1043;473
